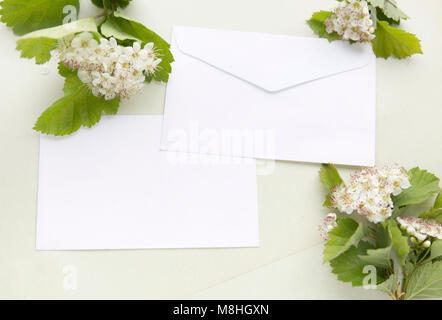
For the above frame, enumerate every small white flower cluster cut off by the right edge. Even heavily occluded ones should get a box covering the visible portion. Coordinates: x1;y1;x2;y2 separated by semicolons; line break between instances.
396;217;442;248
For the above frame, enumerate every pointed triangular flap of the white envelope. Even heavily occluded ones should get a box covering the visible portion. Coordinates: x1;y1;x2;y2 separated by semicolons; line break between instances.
173;26;373;92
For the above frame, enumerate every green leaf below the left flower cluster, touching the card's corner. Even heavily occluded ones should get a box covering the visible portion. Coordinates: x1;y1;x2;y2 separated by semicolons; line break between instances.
34;66;119;136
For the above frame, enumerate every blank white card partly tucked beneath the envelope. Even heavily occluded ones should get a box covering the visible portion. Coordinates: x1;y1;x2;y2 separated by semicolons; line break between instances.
37;116;259;250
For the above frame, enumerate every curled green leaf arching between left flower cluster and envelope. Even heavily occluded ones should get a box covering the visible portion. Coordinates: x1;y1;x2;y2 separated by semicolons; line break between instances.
101;12;174;82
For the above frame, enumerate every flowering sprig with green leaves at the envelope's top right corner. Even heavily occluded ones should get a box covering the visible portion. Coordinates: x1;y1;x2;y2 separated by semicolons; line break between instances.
307;0;423;59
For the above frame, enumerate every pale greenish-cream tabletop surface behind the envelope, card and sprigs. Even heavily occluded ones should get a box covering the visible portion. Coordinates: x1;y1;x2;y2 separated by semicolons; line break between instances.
0;0;442;299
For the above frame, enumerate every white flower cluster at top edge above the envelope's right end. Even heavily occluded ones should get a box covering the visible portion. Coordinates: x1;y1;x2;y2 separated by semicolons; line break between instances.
324;0;375;42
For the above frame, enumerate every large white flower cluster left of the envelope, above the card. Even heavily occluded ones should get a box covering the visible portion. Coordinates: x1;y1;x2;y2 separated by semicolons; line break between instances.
58;32;161;100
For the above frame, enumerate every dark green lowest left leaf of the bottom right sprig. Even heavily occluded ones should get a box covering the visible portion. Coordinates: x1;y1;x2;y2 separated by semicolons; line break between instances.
330;241;380;286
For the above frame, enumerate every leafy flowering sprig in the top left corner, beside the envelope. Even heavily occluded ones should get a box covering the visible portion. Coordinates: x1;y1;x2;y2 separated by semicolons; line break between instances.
0;0;174;135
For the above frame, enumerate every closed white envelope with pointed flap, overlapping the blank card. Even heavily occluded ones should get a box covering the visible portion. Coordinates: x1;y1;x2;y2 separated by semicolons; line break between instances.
161;26;376;166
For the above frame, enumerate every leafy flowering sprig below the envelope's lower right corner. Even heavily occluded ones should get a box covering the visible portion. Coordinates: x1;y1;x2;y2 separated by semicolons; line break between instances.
319;164;442;300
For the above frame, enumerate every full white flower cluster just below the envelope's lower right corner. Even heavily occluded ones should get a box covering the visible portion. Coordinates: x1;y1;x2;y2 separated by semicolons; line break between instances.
330;165;410;223
